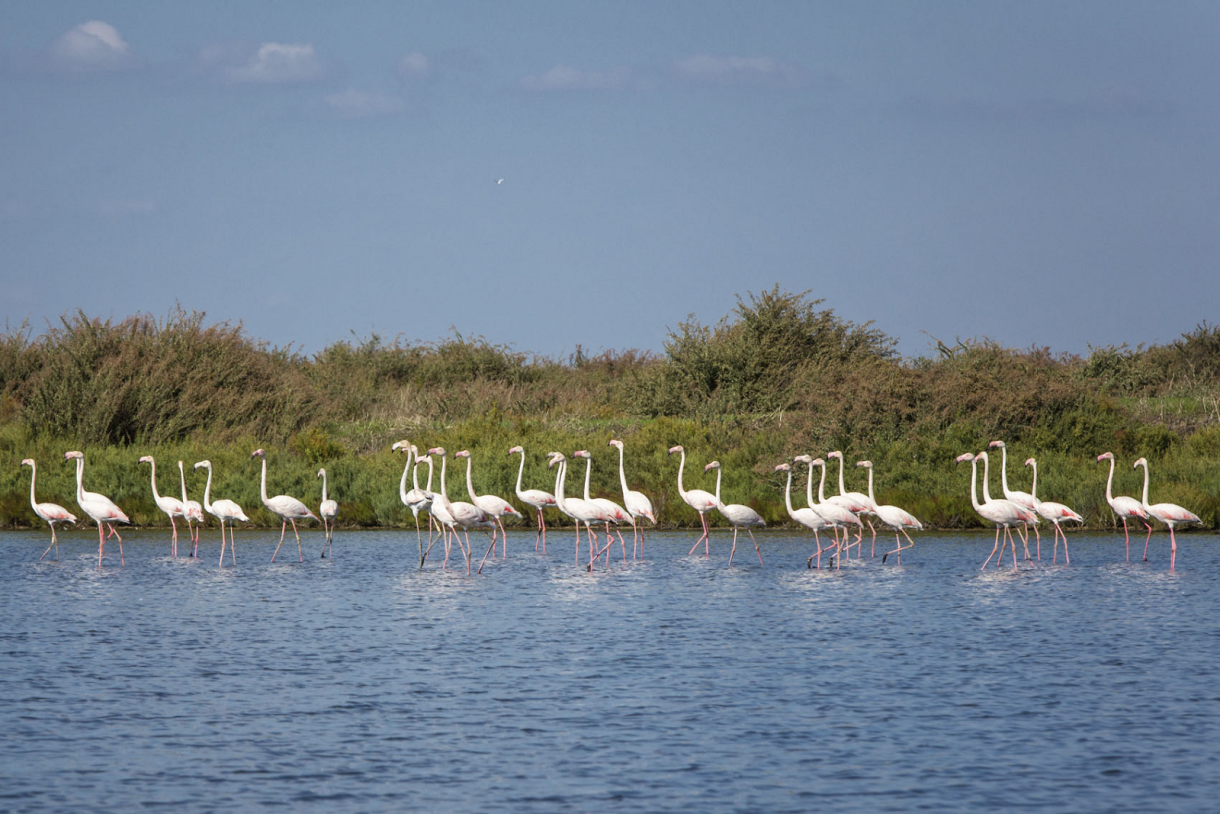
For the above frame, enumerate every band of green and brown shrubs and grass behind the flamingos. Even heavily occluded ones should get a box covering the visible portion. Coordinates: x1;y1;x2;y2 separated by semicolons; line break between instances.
0;287;1220;528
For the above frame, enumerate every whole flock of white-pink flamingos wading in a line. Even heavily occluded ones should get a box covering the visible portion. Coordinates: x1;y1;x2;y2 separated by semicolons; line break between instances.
22;441;1200;574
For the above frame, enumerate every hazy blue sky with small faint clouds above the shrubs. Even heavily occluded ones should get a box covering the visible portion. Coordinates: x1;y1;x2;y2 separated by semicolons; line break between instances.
0;0;1220;355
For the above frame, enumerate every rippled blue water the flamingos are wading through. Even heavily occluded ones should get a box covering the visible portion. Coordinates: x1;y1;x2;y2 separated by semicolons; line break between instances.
0;528;1220;812
